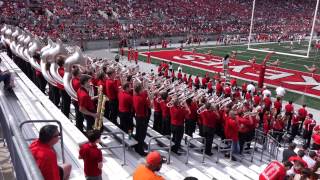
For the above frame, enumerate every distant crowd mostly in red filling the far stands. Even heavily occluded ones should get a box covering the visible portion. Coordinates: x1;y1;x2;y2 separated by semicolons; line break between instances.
1;0;318;40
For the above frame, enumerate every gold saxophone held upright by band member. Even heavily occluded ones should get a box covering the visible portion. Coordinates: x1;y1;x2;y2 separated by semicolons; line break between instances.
93;85;107;130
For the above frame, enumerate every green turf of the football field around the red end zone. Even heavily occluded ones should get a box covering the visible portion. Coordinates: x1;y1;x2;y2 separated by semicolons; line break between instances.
122;42;320;109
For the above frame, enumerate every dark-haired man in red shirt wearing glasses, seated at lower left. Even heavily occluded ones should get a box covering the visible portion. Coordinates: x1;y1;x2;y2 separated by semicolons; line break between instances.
29;125;71;180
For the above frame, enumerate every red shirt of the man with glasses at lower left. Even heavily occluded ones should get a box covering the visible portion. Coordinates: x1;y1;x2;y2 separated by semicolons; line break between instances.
29;140;60;180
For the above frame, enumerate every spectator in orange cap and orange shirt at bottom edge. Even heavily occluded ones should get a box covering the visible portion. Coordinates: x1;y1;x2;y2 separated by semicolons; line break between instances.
133;151;166;180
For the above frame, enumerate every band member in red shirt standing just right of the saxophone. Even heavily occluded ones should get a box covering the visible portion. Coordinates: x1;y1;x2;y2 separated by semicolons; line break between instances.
105;69;119;125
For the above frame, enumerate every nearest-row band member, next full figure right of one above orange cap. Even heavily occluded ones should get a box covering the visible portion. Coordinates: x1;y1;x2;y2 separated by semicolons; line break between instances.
170;99;190;155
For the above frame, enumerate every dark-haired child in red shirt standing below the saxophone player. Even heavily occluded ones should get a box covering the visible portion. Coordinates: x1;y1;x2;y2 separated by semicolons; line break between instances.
79;130;103;180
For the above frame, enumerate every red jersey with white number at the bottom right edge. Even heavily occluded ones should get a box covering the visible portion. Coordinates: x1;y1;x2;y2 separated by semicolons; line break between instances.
259;161;286;180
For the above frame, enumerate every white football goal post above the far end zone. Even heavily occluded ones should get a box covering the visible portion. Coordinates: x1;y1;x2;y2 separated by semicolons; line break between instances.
247;0;320;58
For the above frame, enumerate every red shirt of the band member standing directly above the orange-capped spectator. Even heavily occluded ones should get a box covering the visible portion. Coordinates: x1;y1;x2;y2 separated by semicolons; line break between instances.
133;94;149;118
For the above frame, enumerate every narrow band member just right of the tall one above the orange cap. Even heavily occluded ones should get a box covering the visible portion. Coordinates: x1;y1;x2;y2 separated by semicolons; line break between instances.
152;92;162;133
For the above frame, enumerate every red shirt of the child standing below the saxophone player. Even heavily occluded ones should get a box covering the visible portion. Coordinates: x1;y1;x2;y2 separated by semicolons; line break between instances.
79;143;102;176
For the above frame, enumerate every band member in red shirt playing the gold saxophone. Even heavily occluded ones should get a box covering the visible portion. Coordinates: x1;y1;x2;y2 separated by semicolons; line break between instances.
77;74;98;131
